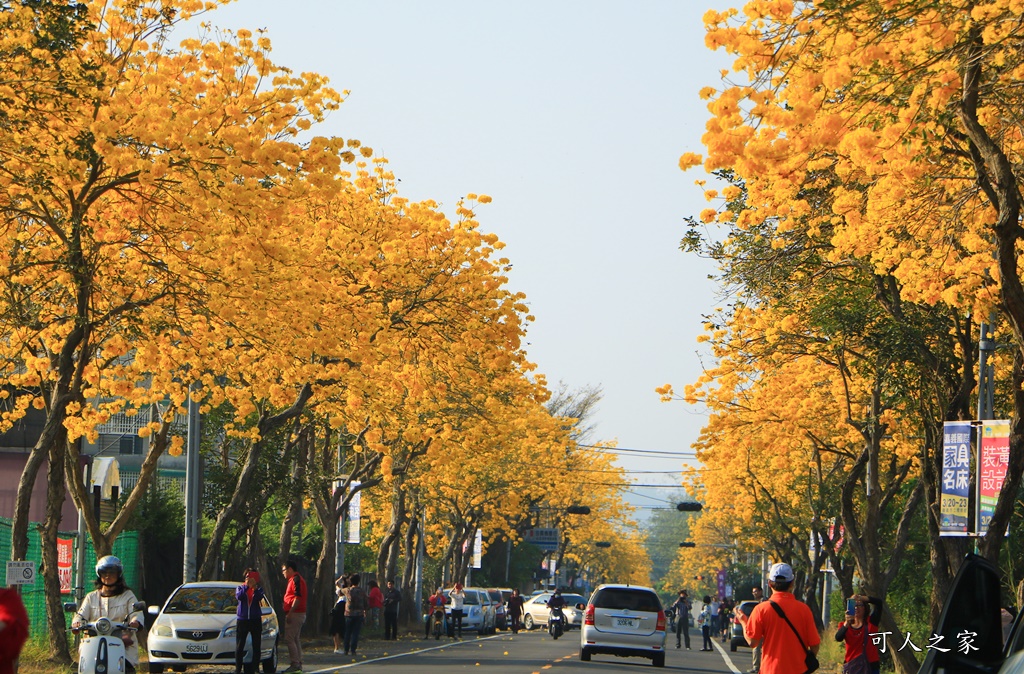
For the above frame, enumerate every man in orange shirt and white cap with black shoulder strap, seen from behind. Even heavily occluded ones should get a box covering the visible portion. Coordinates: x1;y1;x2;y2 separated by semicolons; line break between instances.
737;563;821;674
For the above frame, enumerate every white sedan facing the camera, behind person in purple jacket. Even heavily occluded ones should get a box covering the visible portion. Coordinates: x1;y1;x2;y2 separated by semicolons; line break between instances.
147;582;279;674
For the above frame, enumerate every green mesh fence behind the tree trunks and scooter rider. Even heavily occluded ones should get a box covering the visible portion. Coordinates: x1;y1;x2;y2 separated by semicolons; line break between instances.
0;517;138;637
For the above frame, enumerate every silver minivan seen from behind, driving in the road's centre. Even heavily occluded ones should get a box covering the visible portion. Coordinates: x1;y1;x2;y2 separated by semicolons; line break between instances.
580;584;668;667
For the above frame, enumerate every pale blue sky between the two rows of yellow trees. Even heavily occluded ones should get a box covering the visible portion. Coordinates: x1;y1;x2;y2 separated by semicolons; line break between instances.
190;0;736;512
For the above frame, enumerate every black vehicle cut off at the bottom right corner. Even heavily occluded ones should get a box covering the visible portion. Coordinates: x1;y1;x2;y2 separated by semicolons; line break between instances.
918;554;1024;674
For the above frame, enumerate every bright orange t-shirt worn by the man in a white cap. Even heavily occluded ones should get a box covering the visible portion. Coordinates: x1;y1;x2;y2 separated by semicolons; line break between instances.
743;591;821;674
